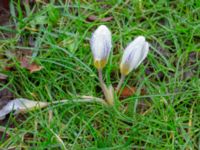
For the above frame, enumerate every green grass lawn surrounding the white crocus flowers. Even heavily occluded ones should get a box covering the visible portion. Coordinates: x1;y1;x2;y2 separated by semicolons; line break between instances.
0;0;200;149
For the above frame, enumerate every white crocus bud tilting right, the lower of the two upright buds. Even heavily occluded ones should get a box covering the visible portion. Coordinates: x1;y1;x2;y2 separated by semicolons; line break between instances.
120;36;149;76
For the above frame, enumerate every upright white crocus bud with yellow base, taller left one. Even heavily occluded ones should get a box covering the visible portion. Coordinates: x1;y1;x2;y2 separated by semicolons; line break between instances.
90;25;112;69
